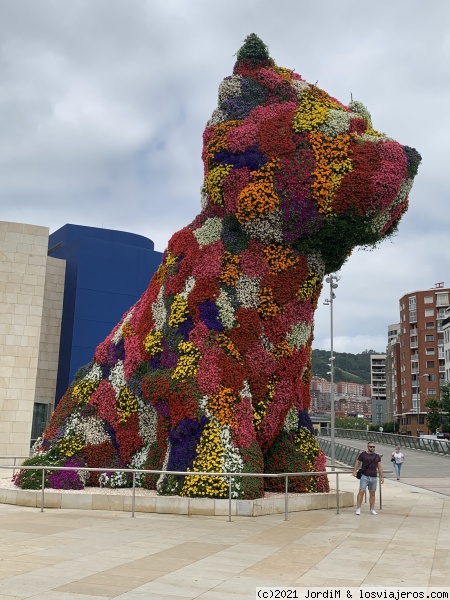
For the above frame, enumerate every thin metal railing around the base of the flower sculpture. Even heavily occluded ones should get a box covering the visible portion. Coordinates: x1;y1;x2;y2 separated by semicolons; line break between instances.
2;464;349;522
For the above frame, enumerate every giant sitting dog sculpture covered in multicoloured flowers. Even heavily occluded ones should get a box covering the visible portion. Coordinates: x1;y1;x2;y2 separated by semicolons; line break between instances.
16;34;420;498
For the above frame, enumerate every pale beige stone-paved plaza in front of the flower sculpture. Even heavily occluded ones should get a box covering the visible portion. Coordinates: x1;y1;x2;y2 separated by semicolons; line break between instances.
0;441;450;600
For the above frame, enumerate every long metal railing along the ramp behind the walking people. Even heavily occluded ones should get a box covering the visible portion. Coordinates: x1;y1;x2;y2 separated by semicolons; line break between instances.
320;427;450;455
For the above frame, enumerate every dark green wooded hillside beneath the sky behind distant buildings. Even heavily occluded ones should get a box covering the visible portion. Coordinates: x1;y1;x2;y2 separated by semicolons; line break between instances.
312;350;380;383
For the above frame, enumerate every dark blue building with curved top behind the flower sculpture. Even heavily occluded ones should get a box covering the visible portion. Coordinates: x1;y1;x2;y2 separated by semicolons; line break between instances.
48;225;162;406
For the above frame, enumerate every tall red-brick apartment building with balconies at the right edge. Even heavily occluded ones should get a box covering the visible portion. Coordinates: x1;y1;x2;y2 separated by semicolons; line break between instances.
394;283;450;435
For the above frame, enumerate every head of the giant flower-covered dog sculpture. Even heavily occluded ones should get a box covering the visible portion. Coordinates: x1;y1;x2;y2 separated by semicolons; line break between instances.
202;34;421;272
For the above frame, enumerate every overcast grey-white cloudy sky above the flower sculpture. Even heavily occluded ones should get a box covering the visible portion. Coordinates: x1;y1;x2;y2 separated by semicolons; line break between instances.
0;0;450;352
